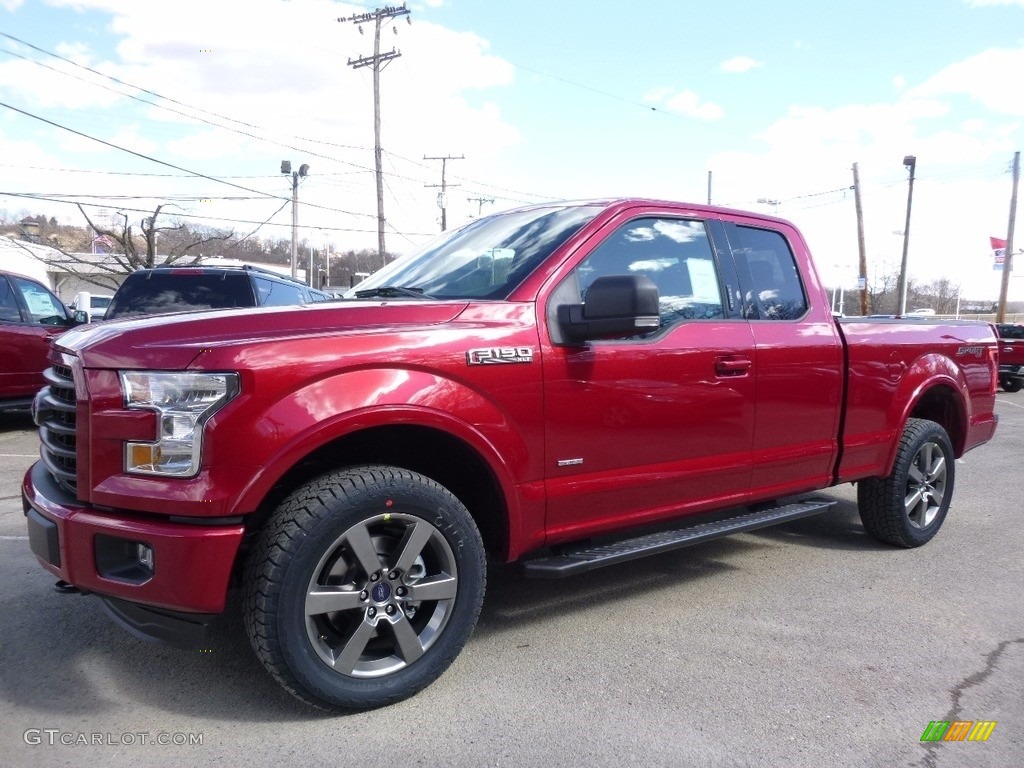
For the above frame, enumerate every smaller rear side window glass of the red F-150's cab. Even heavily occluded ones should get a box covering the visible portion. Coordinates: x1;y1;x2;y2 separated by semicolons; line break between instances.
733;226;807;319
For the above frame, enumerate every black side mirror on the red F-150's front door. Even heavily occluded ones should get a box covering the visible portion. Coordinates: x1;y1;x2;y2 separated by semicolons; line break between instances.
558;274;662;342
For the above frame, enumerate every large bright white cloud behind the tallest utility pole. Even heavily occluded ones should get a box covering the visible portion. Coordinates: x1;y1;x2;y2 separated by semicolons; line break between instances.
0;0;522;248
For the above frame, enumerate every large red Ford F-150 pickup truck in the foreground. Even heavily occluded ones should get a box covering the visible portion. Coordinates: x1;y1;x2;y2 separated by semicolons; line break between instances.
23;200;997;709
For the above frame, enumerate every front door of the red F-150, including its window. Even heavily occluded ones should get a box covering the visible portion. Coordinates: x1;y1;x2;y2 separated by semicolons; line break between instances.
542;208;755;543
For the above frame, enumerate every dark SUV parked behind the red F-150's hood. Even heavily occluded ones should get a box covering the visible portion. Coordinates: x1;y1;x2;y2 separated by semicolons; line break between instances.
104;265;332;319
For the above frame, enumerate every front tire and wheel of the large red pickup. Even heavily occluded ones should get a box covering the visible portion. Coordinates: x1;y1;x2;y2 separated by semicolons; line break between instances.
244;466;486;710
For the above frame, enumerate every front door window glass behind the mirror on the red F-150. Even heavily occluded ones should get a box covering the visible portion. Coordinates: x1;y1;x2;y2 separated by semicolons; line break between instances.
575;218;725;330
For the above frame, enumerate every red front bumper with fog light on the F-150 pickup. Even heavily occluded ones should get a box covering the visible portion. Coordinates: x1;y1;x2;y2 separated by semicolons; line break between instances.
22;462;245;622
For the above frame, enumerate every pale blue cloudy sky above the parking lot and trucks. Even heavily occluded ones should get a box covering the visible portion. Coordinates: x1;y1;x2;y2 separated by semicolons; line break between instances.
0;0;1024;301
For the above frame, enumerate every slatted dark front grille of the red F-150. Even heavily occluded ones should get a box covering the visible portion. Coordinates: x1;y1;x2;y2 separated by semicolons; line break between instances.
36;366;78;495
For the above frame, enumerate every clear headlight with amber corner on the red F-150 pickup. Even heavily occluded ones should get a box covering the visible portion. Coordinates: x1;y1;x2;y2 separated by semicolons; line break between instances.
121;371;239;477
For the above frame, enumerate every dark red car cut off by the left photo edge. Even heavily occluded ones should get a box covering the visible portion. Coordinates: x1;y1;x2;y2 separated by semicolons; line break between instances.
0;272;75;411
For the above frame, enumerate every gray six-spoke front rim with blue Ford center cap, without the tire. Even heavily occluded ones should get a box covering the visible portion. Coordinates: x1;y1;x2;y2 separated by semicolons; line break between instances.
305;513;459;678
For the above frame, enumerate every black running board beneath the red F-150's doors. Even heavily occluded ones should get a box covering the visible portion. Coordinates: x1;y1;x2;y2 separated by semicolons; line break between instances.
523;499;836;579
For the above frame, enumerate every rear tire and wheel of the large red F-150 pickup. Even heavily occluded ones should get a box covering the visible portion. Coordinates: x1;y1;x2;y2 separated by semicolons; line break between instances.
857;419;956;548
